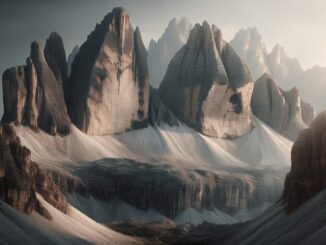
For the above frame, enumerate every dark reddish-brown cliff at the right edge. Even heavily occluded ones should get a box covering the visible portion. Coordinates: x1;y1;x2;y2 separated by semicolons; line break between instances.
283;112;326;212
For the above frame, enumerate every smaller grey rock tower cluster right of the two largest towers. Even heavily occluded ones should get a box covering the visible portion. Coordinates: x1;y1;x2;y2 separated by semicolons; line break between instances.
251;73;314;140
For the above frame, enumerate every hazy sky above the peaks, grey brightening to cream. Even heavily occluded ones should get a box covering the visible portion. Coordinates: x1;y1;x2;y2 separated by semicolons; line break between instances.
0;0;326;76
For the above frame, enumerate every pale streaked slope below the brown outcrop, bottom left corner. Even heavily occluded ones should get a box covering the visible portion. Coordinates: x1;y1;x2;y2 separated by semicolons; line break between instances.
0;196;140;245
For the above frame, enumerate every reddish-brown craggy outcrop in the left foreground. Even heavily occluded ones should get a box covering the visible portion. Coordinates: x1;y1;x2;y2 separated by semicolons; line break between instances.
0;124;68;219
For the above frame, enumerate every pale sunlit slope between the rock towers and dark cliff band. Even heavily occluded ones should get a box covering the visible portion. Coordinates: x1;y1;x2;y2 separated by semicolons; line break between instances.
16;119;292;169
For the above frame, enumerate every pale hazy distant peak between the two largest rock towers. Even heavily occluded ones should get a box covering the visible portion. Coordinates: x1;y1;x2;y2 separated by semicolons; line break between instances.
148;18;192;88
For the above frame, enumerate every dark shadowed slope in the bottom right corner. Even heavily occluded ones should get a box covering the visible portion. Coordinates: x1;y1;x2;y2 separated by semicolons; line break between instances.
227;190;326;244
